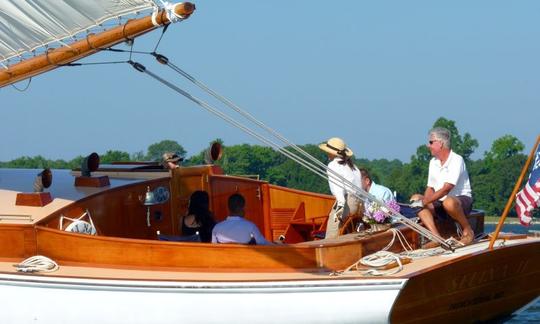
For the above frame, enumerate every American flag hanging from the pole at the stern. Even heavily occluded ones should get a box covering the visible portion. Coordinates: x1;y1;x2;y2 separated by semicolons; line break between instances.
516;145;540;226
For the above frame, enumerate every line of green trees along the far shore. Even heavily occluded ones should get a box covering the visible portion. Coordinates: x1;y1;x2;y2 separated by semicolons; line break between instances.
0;117;538;216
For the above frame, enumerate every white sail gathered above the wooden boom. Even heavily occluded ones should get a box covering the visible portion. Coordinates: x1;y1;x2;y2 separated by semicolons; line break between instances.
0;0;155;63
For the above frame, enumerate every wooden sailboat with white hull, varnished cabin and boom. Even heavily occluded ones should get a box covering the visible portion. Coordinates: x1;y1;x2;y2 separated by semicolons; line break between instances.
0;0;540;323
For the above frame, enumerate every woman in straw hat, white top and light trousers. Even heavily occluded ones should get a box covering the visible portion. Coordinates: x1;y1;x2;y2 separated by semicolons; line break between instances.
319;137;362;238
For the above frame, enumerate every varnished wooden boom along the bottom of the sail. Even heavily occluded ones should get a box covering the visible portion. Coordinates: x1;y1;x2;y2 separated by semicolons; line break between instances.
0;2;195;88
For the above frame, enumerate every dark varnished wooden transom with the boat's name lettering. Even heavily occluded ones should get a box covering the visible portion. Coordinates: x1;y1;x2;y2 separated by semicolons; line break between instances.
391;241;540;323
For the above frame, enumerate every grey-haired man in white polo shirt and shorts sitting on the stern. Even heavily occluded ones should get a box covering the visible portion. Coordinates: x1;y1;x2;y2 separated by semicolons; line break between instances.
411;127;474;244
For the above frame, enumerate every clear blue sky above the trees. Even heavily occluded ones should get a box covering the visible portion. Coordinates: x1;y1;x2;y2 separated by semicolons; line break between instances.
0;0;540;162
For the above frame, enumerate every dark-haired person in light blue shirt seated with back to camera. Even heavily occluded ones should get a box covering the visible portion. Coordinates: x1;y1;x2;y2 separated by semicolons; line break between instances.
212;194;272;245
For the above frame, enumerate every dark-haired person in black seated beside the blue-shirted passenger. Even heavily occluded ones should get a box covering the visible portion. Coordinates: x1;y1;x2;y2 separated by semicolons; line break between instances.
182;190;216;243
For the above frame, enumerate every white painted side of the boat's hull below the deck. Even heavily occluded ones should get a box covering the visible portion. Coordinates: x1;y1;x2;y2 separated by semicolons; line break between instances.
0;275;407;323
